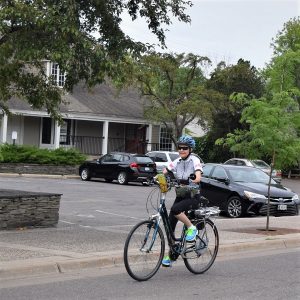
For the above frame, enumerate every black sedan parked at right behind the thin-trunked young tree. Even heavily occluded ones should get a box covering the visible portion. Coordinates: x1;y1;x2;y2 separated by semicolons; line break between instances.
201;163;300;218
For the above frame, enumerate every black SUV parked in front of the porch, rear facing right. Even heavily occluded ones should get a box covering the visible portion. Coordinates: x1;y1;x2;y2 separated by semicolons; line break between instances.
79;152;156;184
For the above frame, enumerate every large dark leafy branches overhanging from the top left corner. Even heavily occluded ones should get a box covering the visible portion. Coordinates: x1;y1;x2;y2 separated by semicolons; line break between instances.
0;0;192;116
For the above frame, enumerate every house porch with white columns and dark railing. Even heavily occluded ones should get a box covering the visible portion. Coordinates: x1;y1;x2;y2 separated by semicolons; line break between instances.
0;114;173;156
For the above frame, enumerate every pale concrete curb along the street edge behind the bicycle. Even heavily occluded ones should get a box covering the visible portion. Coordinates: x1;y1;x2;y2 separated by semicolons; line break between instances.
0;237;300;279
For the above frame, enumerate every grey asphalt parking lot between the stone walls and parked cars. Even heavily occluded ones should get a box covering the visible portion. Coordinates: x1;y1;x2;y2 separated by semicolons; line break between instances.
0;175;300;227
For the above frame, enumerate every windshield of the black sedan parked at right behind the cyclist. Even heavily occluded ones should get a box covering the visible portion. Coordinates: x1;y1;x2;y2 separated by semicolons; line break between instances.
228;168;276;184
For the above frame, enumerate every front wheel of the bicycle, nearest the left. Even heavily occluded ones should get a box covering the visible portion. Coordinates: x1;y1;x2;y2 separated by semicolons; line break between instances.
124;220;165;281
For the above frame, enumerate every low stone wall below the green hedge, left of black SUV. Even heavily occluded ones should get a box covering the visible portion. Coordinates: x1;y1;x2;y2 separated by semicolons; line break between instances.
0;163;79;175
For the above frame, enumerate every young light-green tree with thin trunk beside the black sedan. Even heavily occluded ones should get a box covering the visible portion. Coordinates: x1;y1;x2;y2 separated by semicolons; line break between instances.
217;91;300;230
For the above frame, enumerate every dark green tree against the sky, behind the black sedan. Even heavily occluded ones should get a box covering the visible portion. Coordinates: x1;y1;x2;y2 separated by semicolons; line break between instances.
203;59;264;162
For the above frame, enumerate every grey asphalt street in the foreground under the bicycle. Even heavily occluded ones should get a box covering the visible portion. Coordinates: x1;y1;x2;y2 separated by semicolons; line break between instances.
0;249;300;300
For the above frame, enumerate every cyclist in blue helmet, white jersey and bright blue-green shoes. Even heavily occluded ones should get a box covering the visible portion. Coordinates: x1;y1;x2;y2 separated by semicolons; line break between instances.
162;135;202;267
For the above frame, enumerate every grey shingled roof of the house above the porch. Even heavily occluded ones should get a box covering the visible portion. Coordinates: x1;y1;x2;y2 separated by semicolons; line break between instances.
8;84;145;120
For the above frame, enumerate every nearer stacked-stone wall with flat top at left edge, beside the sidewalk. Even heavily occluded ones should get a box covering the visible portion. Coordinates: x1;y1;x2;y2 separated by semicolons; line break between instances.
0;189;61;230
